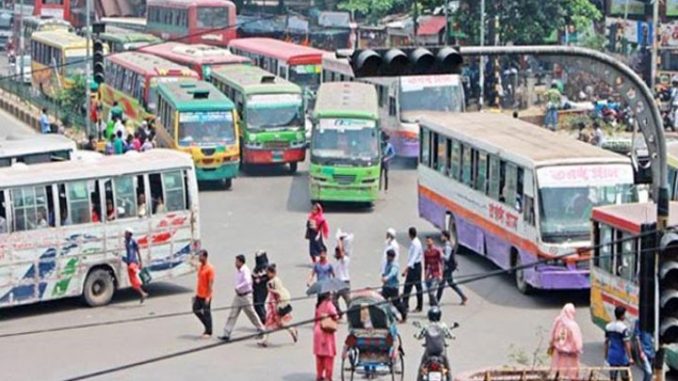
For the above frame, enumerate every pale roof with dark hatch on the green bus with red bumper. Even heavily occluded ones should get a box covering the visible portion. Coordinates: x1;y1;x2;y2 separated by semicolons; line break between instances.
212;65;301;94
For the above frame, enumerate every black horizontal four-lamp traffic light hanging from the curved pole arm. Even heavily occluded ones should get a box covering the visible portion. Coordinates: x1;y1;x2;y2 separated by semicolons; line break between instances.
346;46;463;78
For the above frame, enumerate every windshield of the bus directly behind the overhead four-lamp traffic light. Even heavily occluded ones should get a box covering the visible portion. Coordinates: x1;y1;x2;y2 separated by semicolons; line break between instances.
399;76;464;123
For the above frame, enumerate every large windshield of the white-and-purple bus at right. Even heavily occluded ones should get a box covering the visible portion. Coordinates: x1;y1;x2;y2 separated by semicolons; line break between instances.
537;164;638;243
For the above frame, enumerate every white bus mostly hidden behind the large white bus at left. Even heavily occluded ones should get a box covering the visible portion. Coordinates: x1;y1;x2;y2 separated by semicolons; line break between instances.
0;134;76;168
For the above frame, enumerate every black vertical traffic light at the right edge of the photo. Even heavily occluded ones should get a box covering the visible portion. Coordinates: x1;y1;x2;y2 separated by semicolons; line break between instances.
659;232;678;344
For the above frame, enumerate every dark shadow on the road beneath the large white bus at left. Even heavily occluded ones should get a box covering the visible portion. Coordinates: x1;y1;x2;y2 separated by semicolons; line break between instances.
0;282;193;321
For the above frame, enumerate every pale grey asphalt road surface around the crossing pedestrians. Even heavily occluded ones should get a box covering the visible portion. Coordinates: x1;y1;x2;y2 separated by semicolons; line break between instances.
0;55;636;381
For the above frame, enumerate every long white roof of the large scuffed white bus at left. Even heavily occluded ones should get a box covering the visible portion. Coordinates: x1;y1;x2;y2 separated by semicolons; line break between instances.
0;148;193;188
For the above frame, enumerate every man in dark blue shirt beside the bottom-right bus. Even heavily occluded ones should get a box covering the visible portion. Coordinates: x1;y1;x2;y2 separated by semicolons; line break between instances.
605;306;633;381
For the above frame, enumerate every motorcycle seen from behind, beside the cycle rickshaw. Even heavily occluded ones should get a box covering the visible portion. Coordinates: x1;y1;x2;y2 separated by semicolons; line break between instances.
412;321;459;381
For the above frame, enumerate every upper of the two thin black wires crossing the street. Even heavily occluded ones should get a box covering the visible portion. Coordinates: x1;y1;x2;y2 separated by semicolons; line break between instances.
0;223;673;339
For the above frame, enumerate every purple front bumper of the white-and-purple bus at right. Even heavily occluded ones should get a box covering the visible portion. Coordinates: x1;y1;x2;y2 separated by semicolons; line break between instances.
525;266;591;290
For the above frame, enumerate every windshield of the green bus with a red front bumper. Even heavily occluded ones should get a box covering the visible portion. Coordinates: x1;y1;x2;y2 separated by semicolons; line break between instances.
246;94;304;129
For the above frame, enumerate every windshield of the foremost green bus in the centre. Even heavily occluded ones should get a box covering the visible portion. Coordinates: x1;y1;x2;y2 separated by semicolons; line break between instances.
311;119;379;165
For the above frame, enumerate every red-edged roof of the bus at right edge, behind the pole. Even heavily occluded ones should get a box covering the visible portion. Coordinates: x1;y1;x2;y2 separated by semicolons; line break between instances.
591;201;678;234
